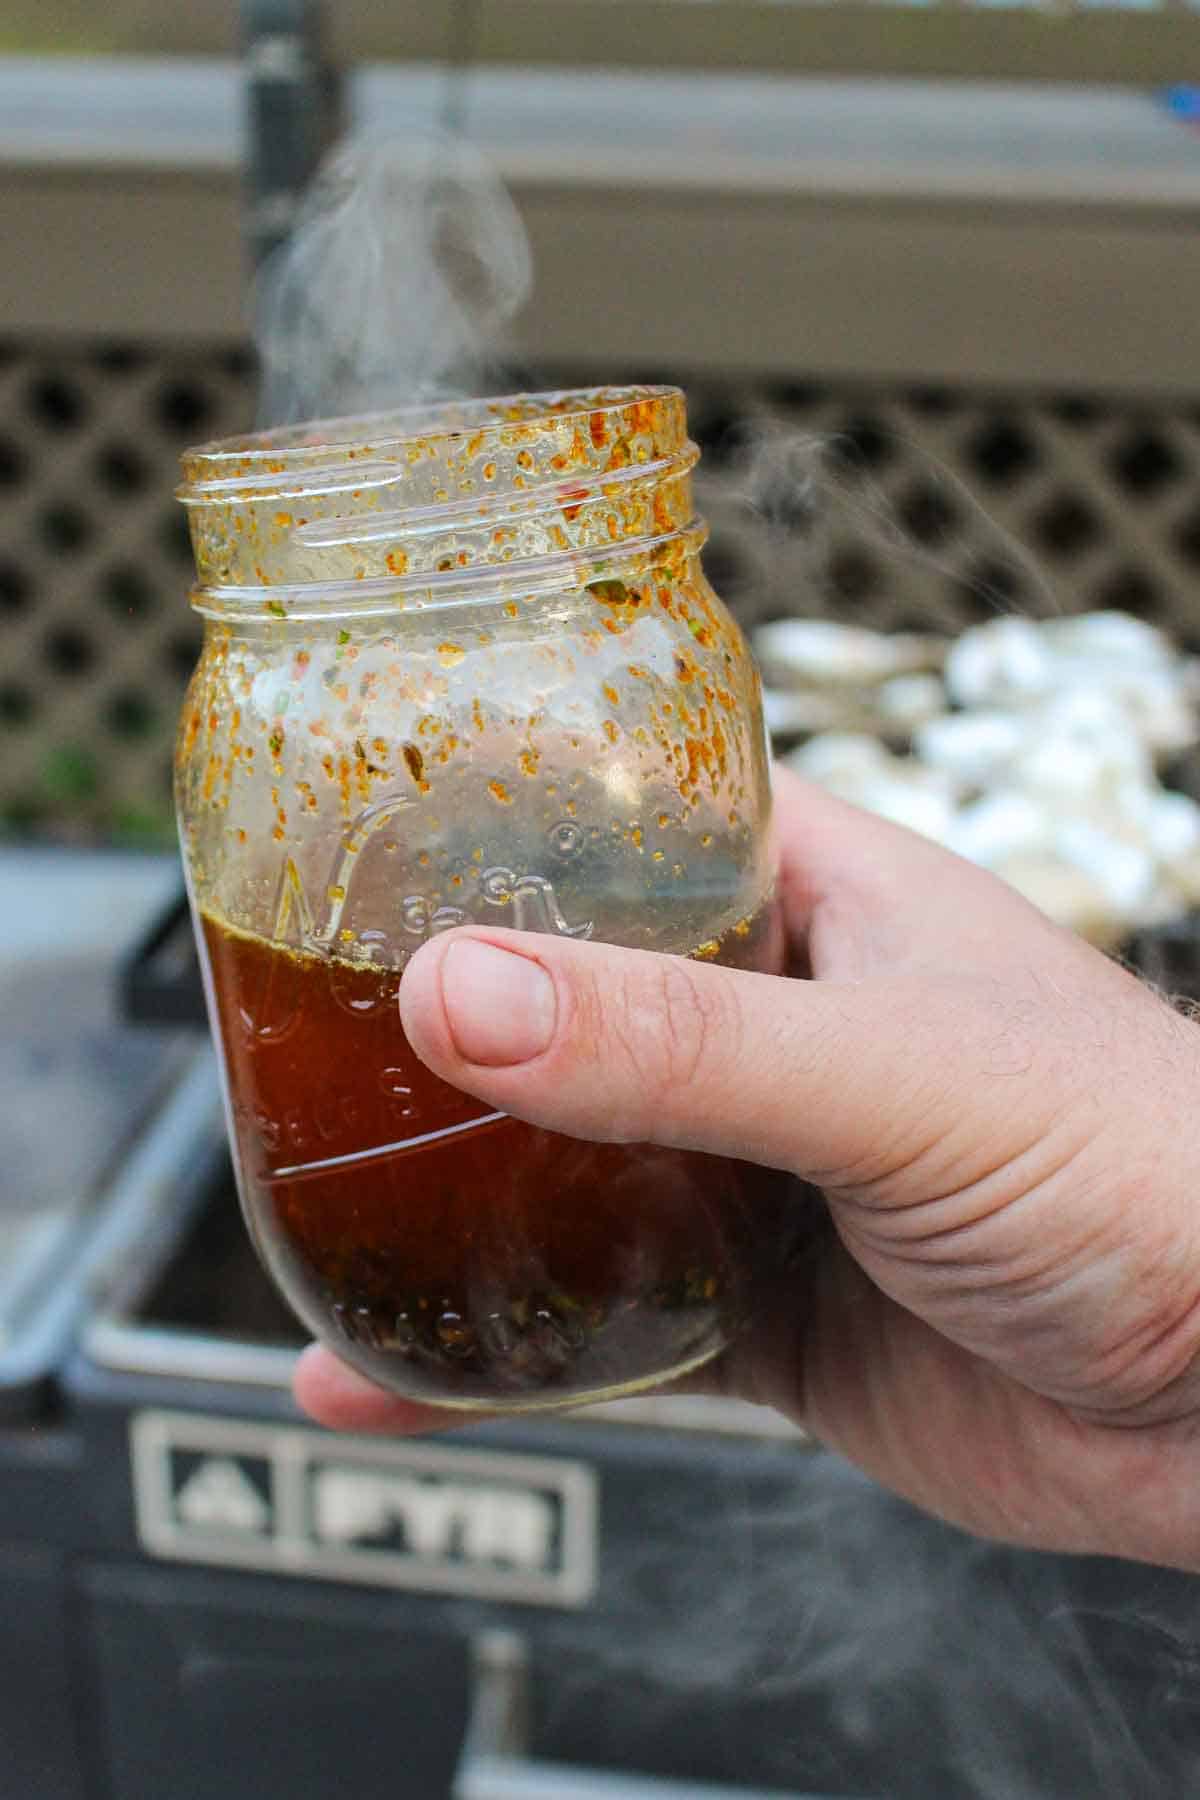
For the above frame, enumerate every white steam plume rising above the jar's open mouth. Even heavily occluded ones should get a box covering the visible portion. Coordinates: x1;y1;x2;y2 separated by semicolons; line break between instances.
255;137;531;425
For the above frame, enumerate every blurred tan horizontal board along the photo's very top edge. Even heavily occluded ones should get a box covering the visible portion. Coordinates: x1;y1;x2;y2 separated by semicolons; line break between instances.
14;0;1200;85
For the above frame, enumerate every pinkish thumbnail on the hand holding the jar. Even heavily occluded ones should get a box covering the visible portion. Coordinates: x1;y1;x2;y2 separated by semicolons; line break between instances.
441;938;558;1069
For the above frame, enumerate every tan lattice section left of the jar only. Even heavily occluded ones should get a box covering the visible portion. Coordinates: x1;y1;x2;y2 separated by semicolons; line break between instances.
0;347;250;839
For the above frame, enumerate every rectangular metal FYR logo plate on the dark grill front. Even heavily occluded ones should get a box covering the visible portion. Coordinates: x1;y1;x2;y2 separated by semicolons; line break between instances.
130;1411;596;1606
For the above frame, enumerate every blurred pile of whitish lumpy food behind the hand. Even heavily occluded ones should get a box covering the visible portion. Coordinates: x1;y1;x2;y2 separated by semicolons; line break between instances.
756;612;1200;945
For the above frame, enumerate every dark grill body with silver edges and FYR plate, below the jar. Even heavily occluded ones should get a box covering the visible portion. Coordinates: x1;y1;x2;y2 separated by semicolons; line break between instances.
0;862;1196;1800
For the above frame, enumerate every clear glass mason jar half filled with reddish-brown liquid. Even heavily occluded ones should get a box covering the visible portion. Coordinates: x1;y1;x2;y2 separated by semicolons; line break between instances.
178;387;788;1411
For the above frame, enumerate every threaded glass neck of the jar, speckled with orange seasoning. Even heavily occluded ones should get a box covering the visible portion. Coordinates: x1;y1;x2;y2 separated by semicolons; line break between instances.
178;385;703;617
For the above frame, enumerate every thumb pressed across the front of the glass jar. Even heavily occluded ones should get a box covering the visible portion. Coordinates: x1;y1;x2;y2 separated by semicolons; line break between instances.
399;929;957;1184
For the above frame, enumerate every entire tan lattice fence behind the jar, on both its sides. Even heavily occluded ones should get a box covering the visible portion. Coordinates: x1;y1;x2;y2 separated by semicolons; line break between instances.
0;346;1200;841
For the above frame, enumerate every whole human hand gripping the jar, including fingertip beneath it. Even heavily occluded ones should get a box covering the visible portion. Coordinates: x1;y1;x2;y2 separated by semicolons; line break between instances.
297;770;1200;1568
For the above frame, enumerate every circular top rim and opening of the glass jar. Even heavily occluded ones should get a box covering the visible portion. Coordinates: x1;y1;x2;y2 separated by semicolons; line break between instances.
180;383;684;500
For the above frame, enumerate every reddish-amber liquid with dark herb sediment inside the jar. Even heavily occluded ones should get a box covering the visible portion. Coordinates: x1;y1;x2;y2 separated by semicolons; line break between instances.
203;907;795;1409
